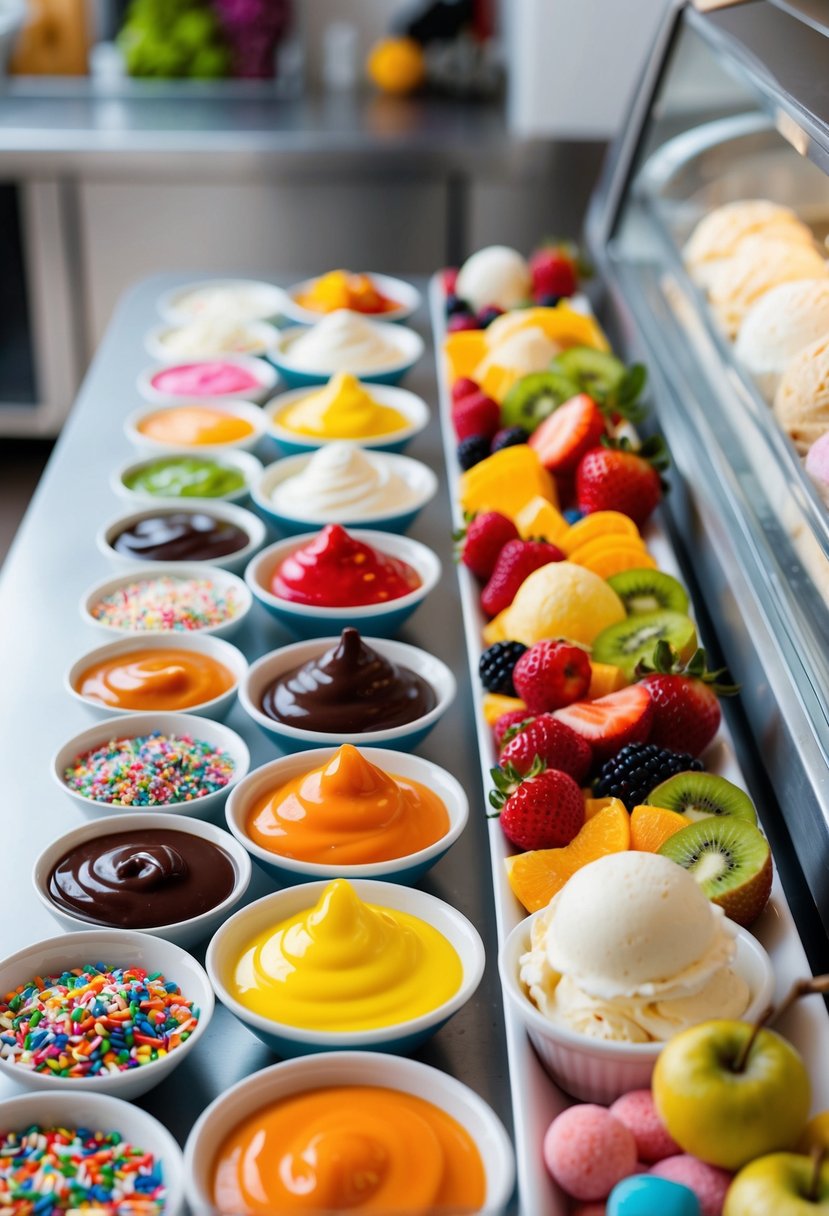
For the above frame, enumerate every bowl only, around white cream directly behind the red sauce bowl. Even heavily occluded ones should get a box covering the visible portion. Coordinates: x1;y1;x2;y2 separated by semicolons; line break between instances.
250;451;438;536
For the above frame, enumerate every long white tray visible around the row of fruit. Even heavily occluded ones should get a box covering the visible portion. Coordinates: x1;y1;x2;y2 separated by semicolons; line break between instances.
429;275;829;1216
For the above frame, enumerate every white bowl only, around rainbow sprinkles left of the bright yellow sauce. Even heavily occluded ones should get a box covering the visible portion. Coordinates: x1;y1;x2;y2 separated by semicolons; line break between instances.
0;927;215;1098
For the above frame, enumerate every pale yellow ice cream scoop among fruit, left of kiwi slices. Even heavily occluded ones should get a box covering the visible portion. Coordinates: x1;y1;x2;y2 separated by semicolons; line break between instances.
484;562;626;646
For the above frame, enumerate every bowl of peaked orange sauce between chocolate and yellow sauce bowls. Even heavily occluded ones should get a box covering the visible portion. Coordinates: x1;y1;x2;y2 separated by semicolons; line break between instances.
225;744;469;885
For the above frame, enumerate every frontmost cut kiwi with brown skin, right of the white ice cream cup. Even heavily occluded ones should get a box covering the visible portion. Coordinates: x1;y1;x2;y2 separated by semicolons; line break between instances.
659;816;772;925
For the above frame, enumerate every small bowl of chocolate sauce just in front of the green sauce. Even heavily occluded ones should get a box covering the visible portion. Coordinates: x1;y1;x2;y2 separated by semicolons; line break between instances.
97;499;266;573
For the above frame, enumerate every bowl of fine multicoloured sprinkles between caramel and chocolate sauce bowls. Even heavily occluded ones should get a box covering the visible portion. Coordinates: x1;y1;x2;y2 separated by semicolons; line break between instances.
52;714;245;820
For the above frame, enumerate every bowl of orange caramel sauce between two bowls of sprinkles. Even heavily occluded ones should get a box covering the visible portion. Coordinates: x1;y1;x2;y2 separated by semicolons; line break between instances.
63;634;248;720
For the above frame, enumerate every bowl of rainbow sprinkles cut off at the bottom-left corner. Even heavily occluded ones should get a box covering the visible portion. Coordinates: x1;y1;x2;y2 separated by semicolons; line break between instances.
0;1090;184;1216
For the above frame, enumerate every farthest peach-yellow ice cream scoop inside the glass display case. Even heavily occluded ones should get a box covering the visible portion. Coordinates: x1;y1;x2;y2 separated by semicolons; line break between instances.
683;198;813;289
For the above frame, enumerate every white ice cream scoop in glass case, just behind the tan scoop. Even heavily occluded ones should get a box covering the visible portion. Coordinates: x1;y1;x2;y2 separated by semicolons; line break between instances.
734;278;829;401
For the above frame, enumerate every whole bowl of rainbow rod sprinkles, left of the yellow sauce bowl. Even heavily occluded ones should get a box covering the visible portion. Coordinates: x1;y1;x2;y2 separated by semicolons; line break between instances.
0;929;215;1104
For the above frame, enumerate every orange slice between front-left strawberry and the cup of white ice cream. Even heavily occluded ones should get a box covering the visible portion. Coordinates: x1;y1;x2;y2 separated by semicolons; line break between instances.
506;798;631;912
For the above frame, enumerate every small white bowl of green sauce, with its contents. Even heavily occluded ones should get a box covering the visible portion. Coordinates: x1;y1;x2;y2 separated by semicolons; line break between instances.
112;451;263;502
